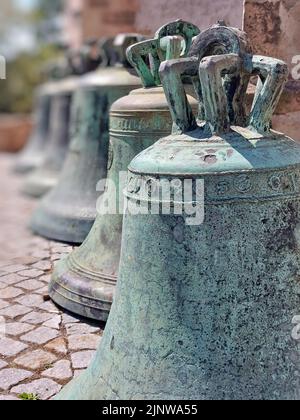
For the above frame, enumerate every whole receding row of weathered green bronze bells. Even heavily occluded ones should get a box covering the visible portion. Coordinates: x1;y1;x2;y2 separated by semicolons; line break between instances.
16;20;300;400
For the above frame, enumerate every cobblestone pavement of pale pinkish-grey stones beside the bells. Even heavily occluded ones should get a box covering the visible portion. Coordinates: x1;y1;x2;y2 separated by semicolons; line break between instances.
0;154;103;400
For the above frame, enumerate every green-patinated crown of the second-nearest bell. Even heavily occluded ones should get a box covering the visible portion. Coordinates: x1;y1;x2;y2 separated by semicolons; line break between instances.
127;20;200;88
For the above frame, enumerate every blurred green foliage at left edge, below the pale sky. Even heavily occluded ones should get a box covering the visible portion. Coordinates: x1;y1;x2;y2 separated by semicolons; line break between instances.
0;46;59;113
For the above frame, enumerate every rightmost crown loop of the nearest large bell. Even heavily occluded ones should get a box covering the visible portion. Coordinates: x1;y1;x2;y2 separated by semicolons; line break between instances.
250;55;288;134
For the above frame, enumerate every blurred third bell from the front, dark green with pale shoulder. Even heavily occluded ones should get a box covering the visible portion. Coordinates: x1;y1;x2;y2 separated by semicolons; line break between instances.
31;34;141;244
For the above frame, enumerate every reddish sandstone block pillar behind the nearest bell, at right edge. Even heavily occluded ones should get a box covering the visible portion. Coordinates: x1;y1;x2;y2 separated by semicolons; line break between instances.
244;0;300;141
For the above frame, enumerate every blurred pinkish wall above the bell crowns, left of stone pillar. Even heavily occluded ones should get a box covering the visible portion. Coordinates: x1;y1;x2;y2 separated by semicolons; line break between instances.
76;0;243;38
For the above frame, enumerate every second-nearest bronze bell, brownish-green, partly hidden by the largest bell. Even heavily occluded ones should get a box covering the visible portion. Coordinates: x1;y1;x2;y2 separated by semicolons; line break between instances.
49;21;199;321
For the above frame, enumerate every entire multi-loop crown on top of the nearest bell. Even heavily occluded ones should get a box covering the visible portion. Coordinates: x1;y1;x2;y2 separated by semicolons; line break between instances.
160;26;288;134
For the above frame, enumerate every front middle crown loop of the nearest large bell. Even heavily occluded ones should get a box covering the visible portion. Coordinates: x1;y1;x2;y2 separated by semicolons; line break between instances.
199;54;243;135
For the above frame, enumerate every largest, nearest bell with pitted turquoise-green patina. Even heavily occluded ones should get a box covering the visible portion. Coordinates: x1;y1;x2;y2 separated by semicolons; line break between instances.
58;23;300;400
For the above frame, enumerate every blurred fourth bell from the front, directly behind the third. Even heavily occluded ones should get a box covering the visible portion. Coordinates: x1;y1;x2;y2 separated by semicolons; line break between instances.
22;46;97;197
